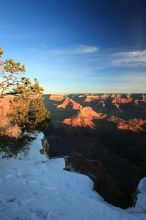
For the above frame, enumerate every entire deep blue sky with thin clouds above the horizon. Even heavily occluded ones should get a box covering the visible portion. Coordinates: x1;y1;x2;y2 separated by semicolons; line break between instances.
0;0;146;93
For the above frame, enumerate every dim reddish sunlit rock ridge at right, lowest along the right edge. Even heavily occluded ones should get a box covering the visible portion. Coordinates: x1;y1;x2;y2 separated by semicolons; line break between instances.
109;116;146;133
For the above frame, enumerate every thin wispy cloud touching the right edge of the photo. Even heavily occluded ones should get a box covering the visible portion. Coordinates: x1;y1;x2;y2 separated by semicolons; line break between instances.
111;50;146;67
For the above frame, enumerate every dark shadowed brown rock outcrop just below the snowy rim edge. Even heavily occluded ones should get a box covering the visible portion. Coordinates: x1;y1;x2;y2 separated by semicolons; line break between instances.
65;152;121;206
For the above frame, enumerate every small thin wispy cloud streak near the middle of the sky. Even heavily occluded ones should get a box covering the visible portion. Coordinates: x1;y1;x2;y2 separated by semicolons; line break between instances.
50;44;99;56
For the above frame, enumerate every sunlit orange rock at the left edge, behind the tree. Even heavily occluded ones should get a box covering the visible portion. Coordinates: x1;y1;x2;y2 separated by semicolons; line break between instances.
0;96;22;138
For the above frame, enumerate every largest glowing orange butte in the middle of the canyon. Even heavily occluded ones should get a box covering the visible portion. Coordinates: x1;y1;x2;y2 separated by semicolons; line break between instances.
63;107;106;128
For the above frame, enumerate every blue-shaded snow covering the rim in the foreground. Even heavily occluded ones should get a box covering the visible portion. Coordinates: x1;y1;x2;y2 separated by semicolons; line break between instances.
0;133;146;220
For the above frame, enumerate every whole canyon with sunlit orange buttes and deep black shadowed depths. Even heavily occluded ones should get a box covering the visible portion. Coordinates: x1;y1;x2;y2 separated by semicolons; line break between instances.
44;93;146;208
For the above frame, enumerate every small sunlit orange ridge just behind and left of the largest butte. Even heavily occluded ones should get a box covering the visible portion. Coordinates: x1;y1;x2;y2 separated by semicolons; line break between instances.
57;98;82;110
